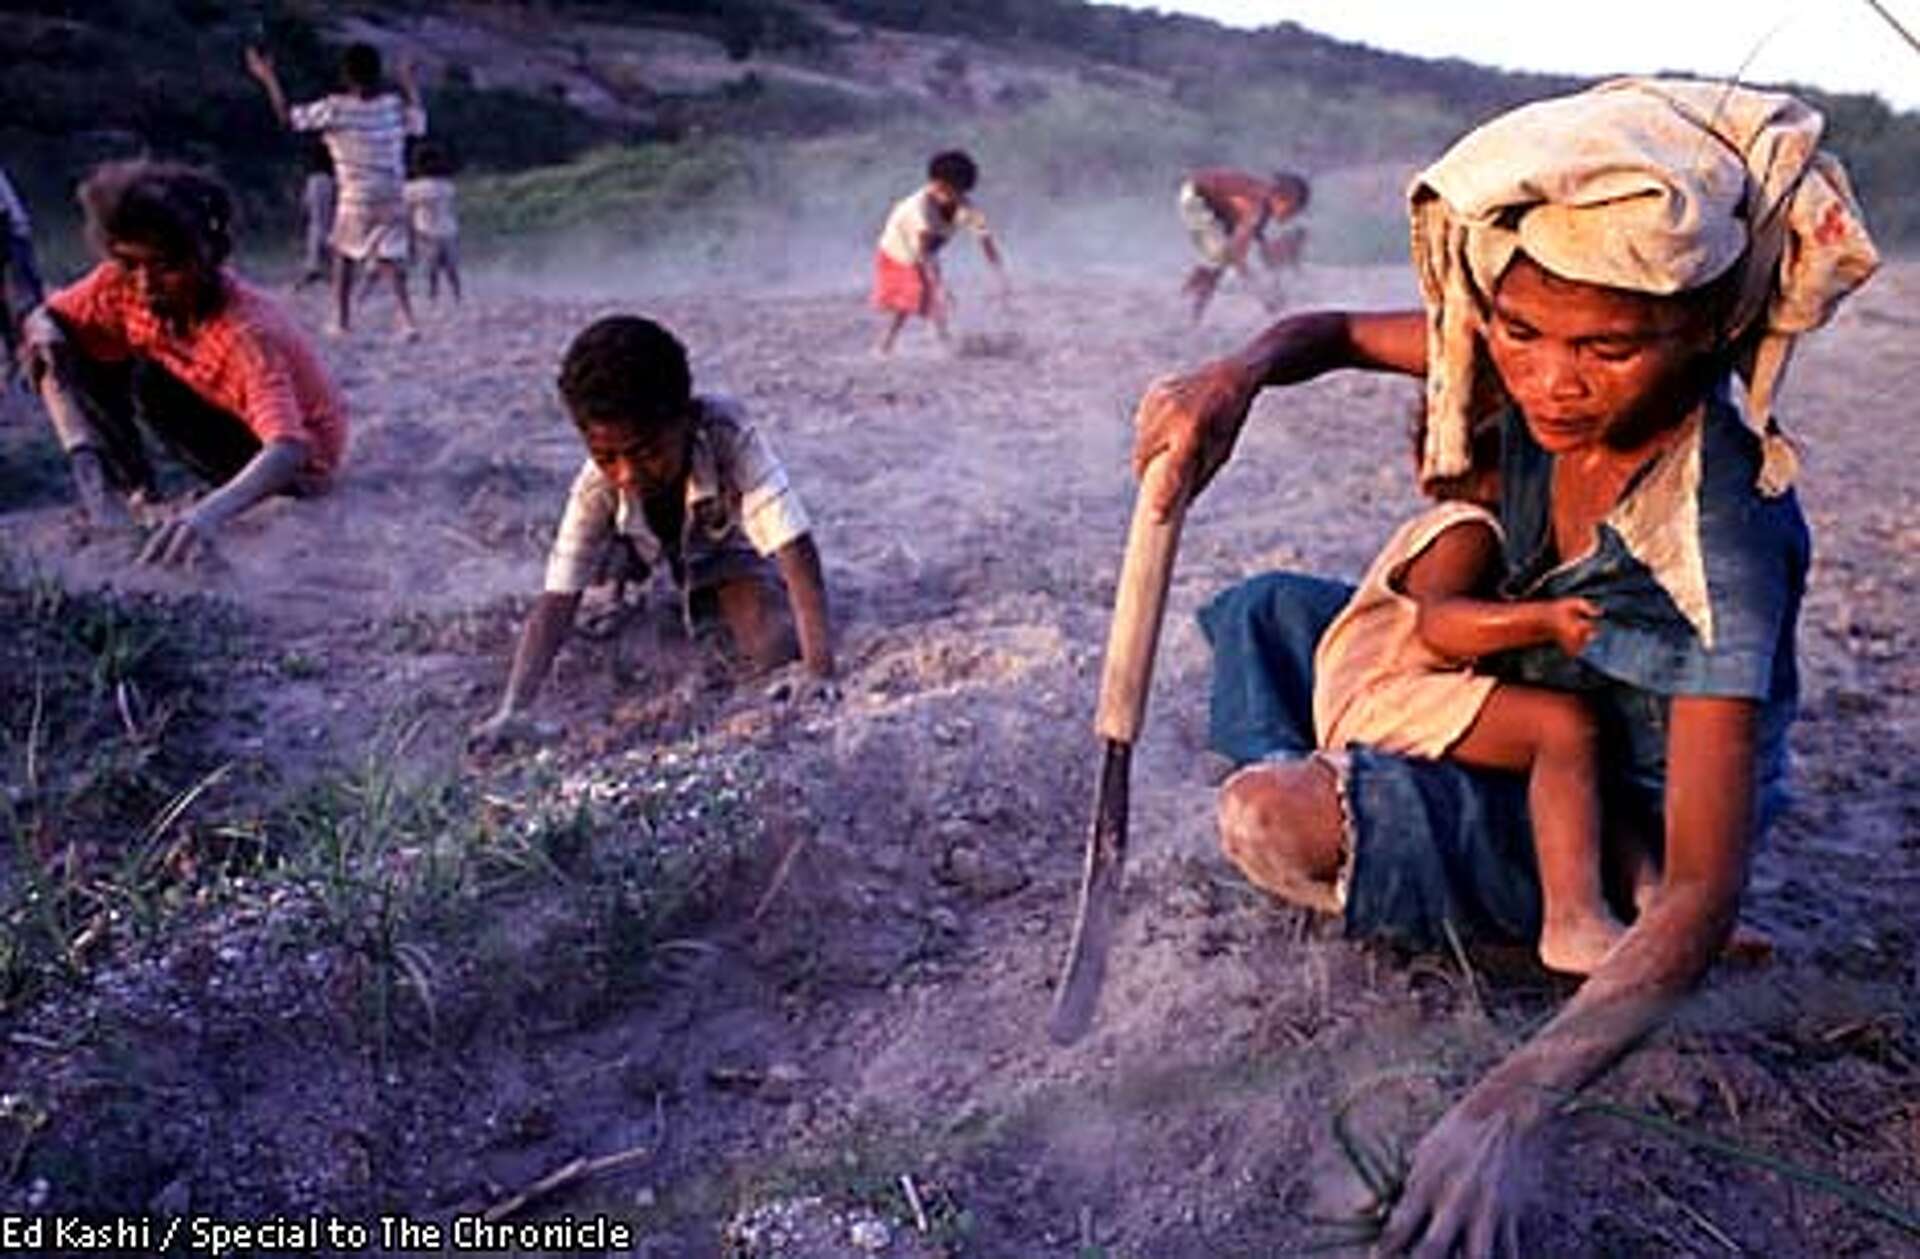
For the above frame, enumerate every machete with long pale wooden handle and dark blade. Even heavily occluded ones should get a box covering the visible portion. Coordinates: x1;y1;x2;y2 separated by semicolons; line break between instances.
1046;457;1187;1044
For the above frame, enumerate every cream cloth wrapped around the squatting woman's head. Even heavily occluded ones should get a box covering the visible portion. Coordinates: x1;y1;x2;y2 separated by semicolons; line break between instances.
1409;79;1880;493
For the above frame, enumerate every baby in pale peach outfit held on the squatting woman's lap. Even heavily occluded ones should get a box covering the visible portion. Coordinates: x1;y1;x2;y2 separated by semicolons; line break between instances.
1313;413;1626;975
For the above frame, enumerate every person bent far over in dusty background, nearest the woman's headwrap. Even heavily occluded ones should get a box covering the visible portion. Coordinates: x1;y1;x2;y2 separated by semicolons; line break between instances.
1179;167;1313;322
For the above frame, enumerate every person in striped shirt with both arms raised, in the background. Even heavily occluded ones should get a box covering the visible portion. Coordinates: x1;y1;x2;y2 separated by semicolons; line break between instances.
246;44;426;340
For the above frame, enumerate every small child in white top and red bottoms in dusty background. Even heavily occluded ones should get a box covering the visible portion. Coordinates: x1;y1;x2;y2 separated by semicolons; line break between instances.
874;150;1006;355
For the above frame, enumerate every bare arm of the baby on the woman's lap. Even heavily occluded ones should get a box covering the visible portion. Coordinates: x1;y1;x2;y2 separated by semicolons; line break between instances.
1400;522;1599;660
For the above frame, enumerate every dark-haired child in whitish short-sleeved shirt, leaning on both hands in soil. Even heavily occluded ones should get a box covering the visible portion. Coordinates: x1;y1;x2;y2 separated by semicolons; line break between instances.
470;315;833;748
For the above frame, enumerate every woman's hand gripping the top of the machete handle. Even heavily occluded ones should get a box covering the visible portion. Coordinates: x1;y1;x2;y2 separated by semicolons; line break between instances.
1133;359;1258;520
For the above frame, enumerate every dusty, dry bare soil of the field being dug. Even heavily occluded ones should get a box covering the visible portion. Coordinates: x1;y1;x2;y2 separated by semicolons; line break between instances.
0;267;1920;1259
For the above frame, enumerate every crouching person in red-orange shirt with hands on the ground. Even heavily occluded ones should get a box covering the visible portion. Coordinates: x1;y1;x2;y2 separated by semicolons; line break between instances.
25;161;348;564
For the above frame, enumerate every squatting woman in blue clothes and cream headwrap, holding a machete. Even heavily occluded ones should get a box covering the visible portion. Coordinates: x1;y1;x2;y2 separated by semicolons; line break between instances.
1135;81;1878;1257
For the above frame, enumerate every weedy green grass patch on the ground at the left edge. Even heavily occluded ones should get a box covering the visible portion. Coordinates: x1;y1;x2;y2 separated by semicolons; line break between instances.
0;568;766;1056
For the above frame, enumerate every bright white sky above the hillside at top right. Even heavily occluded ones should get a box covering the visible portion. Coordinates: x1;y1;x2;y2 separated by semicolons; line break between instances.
1102;0;1920;109
